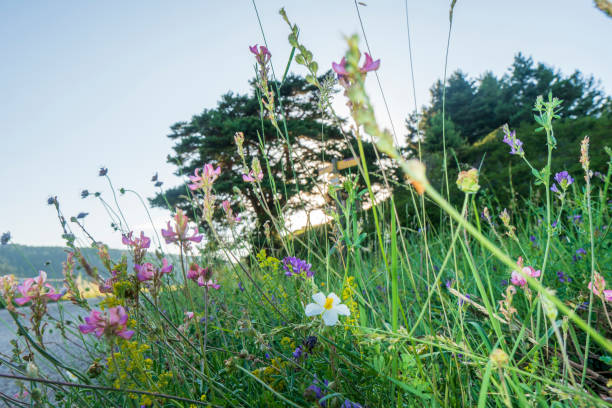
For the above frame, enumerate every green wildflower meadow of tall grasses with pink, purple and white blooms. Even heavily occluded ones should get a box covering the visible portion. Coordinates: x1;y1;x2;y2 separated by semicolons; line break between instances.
0;3;612;408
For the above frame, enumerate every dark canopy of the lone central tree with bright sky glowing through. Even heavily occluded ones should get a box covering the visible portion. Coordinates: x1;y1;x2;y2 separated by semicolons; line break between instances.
151;74;380;231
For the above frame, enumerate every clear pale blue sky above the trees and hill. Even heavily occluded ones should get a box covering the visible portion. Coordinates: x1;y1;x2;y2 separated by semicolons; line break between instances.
0;0;612;247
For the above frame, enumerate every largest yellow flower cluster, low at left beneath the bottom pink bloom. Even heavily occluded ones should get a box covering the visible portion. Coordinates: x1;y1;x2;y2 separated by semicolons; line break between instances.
106;341;173;406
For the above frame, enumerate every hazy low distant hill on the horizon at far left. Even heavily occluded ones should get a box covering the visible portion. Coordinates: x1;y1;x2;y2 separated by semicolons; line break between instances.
0;244;126;279
